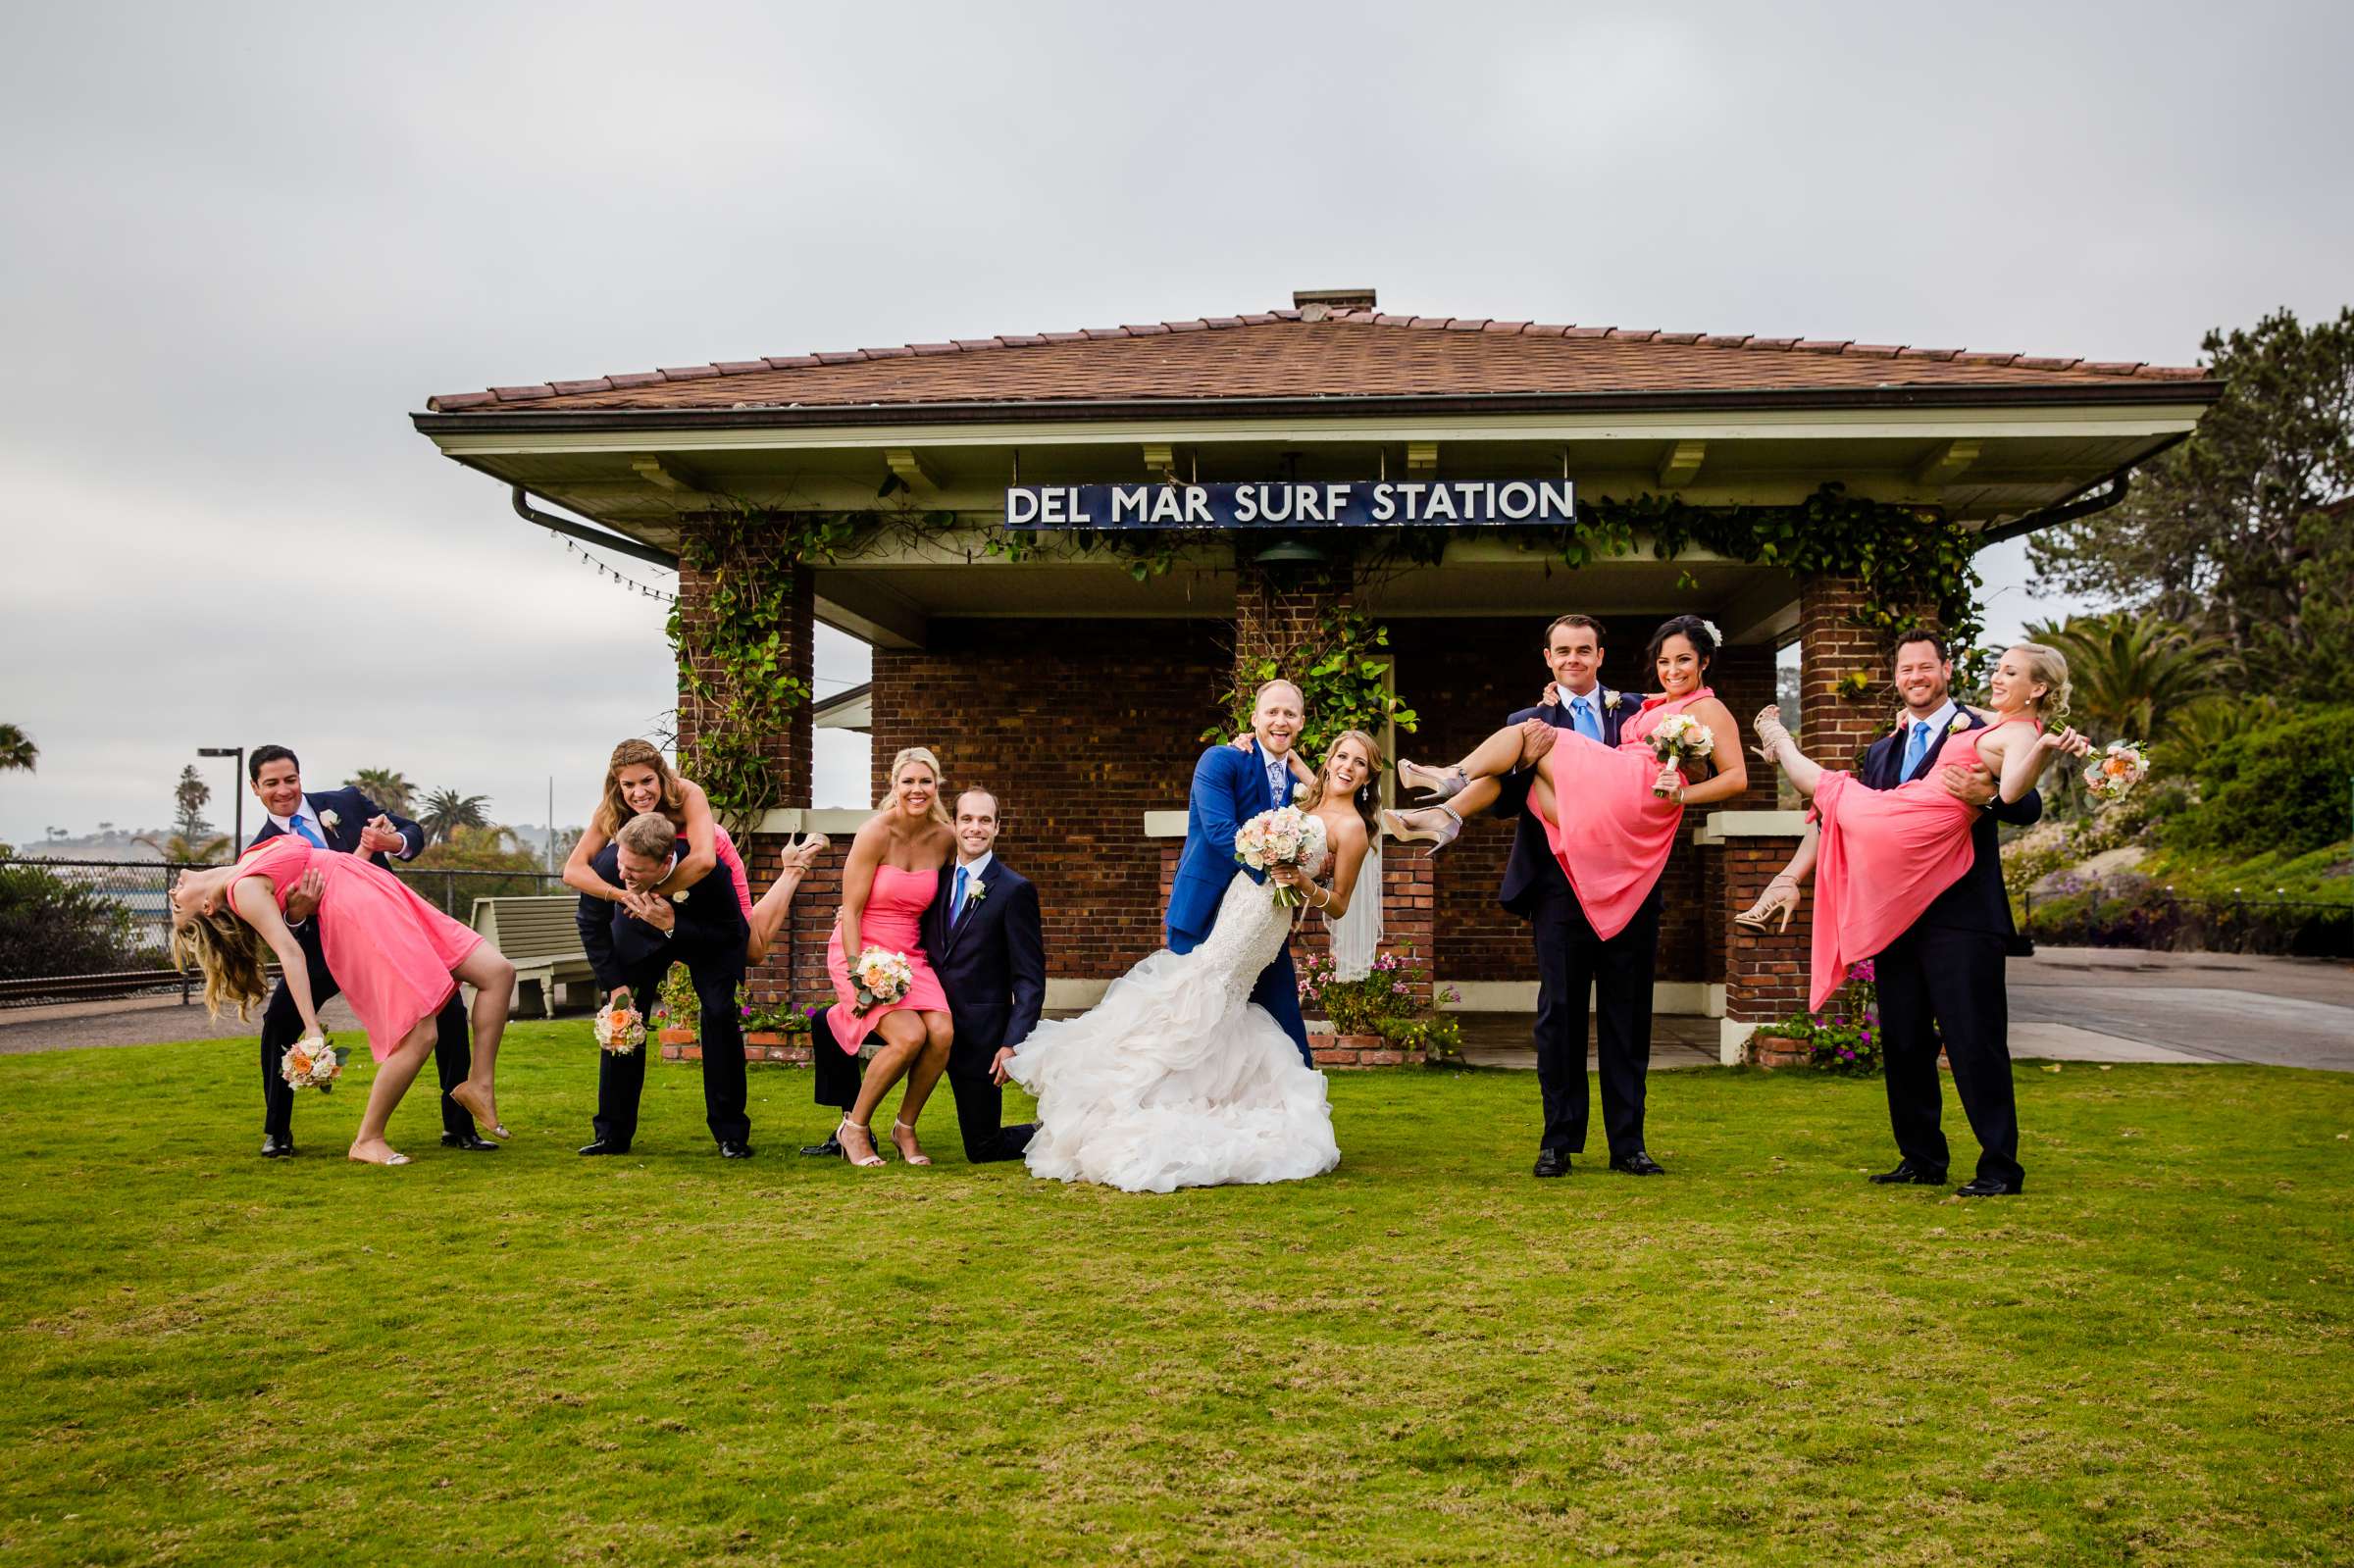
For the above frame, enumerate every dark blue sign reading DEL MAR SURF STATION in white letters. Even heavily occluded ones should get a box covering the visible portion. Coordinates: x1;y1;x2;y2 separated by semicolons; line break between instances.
1005;481;1577;528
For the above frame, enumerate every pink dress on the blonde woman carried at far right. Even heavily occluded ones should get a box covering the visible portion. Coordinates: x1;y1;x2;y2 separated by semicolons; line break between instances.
1806;713;2043;1012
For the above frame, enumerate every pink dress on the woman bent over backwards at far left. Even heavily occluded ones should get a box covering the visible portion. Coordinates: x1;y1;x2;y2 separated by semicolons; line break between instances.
237;834;483;1062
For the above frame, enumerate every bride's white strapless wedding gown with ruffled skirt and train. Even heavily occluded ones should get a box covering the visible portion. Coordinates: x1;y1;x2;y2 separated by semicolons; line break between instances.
1005;817;1340;1191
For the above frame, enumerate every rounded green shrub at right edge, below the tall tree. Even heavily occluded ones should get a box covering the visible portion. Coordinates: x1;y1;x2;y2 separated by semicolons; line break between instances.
2166;704;2354;855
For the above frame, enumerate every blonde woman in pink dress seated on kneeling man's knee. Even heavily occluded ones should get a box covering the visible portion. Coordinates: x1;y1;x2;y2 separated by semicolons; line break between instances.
819;746;955;1165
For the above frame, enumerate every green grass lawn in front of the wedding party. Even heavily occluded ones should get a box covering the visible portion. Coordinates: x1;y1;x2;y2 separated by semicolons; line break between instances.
0;1024;2354;1566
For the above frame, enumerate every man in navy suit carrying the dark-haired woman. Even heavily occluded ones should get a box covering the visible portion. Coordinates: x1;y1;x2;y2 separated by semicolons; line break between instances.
1490;615;1664;1177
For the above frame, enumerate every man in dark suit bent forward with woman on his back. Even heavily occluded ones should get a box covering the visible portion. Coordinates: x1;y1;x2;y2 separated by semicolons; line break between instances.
572;812;753;1161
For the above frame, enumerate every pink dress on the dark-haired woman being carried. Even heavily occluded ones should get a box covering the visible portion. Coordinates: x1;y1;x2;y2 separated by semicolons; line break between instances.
1544;687;1714;927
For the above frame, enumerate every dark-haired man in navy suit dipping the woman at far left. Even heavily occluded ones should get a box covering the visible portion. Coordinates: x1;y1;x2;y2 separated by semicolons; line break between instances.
245;746;483;1161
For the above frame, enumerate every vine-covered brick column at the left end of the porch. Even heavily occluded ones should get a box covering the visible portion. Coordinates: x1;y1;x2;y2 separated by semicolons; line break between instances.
678;521;814;1021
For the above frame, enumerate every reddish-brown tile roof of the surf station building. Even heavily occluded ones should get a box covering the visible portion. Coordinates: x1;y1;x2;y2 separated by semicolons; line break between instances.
426;309;2208;415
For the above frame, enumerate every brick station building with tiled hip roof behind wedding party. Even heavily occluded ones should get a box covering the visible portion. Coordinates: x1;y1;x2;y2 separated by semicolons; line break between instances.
412;289;2220;1062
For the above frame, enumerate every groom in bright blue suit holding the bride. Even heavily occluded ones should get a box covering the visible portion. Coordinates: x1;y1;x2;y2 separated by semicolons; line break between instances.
1167;681;1316;1067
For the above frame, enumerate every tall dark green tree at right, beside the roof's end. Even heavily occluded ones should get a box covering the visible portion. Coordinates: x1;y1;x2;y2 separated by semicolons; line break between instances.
2026;306;2354;699
